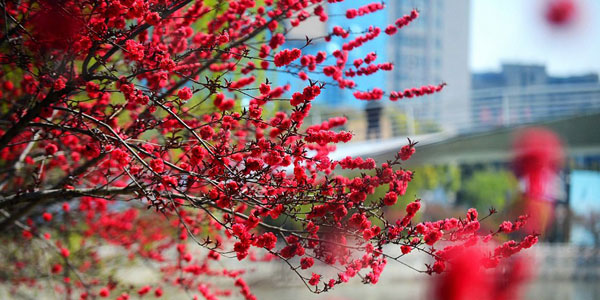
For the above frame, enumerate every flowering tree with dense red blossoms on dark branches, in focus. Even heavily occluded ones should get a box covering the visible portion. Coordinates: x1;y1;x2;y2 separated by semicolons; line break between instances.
0;0;537;299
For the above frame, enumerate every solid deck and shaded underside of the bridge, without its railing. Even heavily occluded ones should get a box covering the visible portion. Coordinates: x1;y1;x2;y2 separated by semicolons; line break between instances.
331;113;600;166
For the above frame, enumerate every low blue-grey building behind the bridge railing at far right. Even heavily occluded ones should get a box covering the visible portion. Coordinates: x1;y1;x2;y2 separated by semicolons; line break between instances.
468;64;600;131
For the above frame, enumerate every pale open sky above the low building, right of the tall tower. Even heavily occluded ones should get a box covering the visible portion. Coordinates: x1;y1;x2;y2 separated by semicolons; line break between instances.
470;0;600;75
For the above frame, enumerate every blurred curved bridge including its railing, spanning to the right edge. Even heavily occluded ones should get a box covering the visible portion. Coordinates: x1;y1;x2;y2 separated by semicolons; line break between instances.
322;84;600;166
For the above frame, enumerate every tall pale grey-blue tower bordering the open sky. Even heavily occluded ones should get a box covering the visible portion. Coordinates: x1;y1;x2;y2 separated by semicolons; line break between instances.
386;0;471;134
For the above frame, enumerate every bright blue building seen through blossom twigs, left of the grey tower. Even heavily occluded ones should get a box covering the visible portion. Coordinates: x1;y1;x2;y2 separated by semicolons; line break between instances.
278;0;389;140
